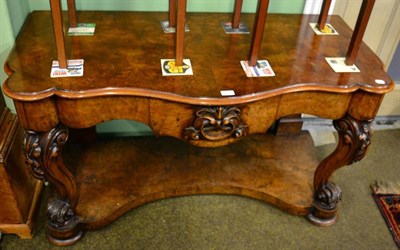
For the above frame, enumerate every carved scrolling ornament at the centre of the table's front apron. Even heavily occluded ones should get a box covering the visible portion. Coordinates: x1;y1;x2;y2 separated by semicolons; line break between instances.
185;107;247;141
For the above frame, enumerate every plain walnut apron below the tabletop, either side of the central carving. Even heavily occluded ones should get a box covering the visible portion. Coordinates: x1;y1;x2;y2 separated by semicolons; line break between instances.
11;91;383;142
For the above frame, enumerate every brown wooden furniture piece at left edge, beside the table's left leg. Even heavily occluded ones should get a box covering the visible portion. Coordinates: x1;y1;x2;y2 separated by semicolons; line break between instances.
0;96;43;239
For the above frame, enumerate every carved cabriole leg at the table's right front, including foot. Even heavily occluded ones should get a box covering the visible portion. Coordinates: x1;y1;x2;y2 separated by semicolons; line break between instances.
308;115;372;226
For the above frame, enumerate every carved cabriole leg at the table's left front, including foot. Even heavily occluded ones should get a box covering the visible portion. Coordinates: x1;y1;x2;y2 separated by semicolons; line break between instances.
24;125;82;245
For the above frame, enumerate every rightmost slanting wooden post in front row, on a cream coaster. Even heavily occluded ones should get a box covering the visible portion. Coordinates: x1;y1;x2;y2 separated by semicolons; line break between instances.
345;0;375;65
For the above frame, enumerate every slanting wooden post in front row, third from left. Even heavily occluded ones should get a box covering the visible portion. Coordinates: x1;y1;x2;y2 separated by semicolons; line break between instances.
249;0;269;67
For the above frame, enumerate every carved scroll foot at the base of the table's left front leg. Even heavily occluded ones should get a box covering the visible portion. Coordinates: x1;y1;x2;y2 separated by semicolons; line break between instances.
47;199;83;246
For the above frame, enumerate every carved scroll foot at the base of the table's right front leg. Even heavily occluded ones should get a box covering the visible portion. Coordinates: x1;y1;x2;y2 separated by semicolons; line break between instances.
307;182;342;226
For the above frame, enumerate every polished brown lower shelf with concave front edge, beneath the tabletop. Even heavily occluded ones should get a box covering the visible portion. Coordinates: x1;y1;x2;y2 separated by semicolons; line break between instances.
66;132;318;229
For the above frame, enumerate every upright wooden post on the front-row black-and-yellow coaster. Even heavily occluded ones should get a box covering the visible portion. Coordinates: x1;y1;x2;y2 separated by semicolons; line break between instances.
175;0;186;66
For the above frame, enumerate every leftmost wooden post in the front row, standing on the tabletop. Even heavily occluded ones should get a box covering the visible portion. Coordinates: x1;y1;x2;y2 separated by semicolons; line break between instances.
50;0;68;69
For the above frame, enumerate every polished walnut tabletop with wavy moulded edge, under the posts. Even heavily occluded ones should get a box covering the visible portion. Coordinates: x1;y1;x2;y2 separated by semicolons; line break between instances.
3;12;394;101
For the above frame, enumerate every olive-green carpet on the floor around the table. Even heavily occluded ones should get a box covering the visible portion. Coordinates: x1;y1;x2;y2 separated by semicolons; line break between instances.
1;130;400;250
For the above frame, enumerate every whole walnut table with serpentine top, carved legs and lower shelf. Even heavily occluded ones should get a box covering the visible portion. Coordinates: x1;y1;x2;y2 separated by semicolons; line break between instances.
3;0;394;245
